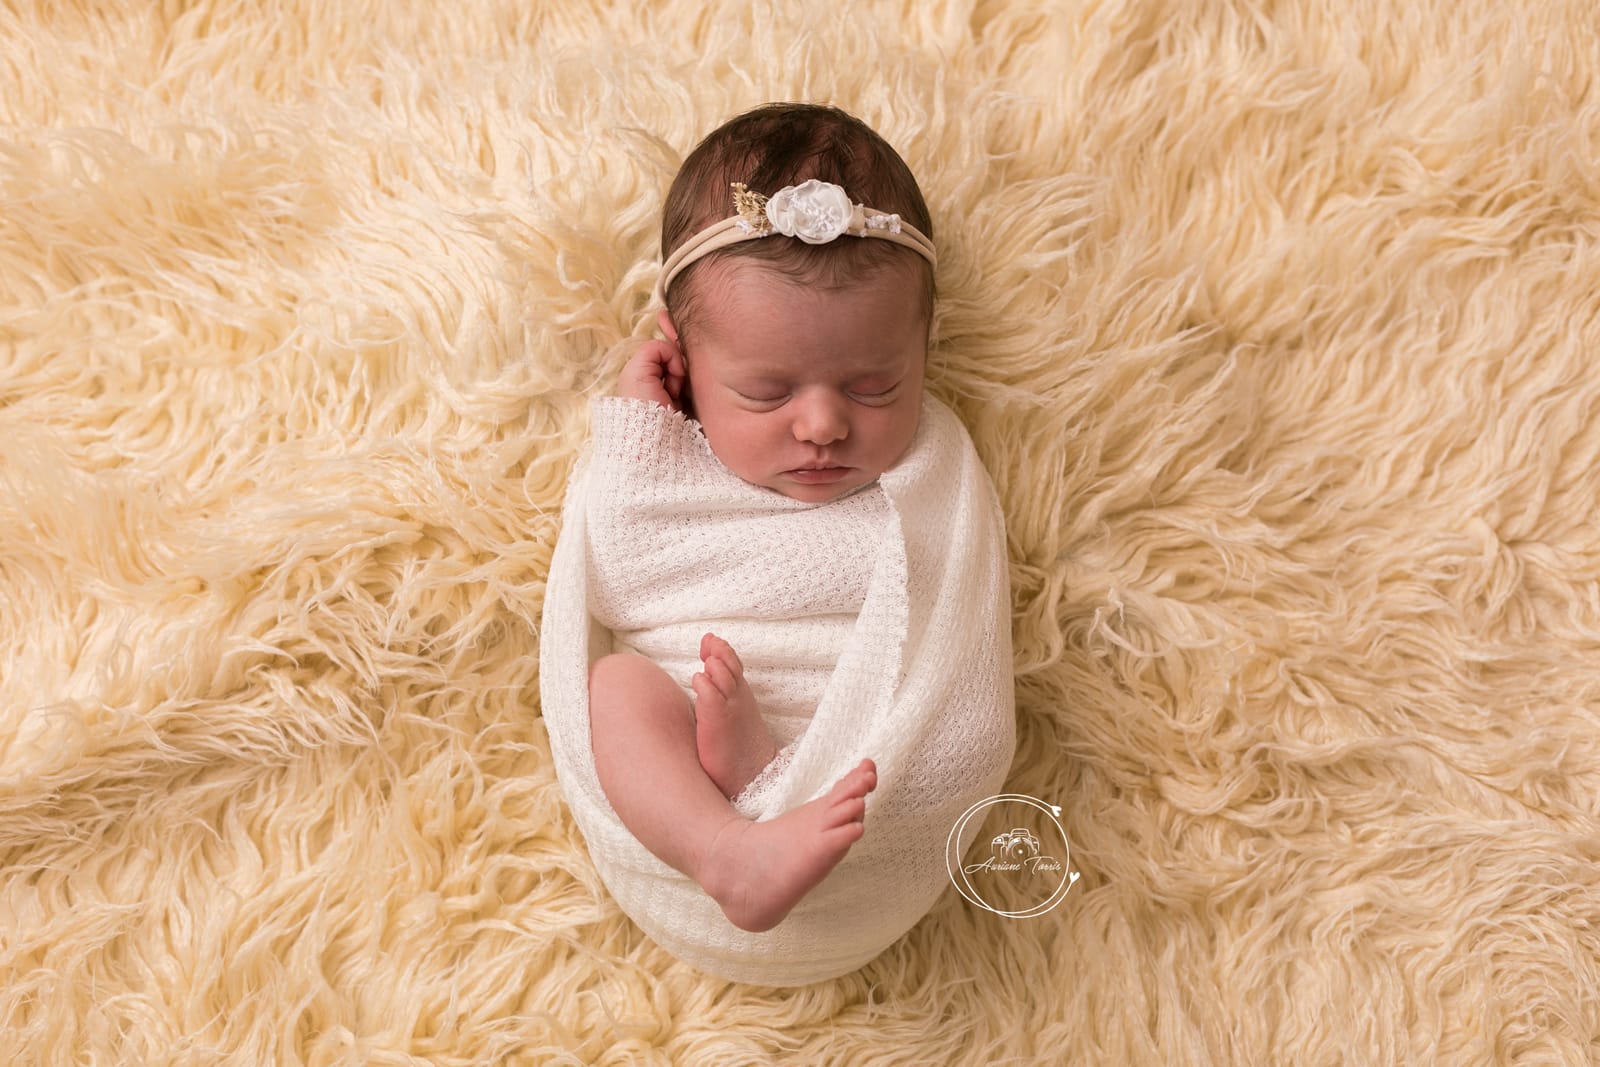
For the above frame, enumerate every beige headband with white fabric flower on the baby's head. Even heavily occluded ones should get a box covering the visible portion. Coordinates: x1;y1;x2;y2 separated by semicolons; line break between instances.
656;178;936;304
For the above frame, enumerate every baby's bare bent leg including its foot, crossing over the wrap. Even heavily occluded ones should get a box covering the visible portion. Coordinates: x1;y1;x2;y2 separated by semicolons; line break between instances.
589;654;877;931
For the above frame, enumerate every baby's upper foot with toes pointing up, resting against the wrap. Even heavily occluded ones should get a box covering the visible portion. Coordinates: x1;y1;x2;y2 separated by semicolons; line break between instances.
690;633;778;800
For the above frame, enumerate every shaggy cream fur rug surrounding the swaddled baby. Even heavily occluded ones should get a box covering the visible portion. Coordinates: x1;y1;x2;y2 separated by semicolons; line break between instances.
0;0;1600;1065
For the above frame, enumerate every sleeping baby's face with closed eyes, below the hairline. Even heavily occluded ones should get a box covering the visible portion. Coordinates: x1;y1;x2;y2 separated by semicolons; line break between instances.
672;259;928;502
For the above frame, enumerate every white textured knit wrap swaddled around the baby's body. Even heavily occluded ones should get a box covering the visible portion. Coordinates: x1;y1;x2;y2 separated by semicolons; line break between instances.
539;397;1014;985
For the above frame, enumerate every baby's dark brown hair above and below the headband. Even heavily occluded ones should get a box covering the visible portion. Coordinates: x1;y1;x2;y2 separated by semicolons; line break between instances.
661;104;934;336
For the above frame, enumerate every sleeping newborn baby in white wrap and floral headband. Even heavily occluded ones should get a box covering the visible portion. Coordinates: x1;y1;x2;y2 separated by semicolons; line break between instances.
541;106;1013;984
